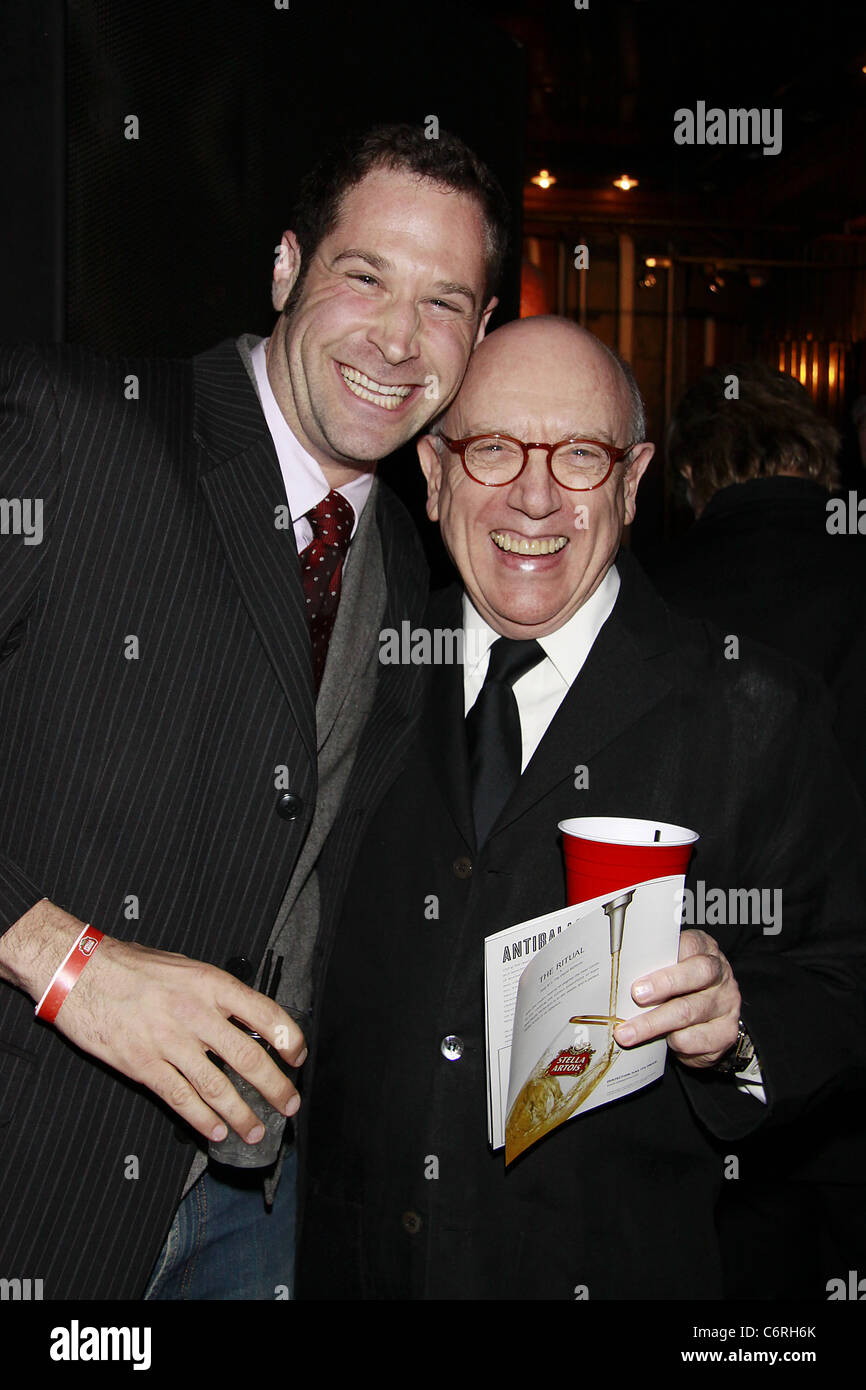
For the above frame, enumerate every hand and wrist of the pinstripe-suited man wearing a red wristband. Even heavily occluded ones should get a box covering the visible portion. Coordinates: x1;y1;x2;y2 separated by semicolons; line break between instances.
0;899;307;1144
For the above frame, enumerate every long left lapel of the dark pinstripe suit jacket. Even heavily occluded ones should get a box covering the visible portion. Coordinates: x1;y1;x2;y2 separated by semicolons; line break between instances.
193;342;316;762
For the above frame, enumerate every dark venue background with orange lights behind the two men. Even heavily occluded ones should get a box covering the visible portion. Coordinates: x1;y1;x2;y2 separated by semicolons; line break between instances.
0;0;866;552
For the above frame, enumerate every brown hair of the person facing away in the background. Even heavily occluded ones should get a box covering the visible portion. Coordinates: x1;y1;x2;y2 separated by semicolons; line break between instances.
667;361;841;507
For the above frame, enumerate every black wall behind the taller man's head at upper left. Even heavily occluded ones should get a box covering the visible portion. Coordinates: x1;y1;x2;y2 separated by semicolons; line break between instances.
0;0;525;356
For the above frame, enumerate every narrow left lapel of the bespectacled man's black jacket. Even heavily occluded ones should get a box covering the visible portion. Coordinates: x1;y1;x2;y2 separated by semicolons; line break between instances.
423;584;475;852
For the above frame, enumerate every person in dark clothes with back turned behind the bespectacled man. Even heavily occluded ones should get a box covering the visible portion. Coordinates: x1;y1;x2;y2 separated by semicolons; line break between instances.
646;363;866;1298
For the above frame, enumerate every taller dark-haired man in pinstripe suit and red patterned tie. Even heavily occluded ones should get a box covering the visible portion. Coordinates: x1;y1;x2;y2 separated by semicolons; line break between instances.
0;128;506;1298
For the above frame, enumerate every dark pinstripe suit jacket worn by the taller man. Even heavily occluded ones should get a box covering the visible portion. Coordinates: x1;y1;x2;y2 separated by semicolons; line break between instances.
0;343;425;1298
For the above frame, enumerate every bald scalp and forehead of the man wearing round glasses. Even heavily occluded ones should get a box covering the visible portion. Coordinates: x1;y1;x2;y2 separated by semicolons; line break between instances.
434;314;646;446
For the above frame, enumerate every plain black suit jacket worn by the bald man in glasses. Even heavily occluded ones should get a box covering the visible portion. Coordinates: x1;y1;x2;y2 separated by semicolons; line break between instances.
299;555;866;1300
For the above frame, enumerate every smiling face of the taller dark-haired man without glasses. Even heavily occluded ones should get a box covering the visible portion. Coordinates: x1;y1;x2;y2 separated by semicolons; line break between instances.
268;170;496;487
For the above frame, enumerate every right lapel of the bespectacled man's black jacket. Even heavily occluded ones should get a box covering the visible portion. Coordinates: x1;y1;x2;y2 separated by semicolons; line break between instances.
491;550;673;838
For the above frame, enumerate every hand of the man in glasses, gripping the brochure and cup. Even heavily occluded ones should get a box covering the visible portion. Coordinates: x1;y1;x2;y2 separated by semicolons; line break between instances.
613;931;741;1068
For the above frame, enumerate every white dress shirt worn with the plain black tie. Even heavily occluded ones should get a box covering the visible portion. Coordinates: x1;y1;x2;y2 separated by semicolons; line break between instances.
463;564;766;1105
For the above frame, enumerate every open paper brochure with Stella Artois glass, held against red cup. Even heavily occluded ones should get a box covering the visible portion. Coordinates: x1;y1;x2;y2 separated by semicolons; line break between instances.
484;874;684;1165
